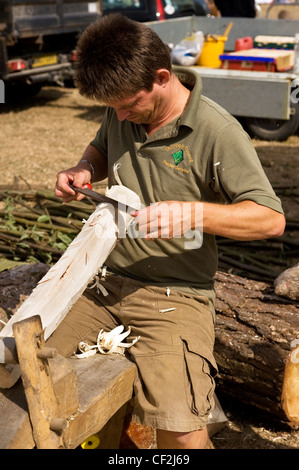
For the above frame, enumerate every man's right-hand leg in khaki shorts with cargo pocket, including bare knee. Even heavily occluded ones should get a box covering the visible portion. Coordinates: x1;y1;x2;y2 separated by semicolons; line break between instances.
123;287;217;449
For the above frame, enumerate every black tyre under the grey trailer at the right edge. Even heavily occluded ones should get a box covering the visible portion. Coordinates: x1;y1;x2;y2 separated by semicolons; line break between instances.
245;105;299;141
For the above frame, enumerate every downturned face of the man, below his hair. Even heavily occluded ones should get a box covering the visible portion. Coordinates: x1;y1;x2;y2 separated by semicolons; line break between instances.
107;84;161;124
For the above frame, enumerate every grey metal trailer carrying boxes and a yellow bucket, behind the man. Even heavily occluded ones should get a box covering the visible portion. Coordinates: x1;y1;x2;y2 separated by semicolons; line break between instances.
148;16;299;140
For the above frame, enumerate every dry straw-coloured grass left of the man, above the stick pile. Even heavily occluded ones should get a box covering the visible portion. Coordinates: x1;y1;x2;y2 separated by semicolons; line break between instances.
0;87;103;188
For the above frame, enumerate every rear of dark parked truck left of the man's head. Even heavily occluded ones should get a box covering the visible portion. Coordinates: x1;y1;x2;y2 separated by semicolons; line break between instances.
0;0;101;97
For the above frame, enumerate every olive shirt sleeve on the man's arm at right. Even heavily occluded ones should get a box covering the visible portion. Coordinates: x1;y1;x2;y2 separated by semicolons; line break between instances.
212;124;283;213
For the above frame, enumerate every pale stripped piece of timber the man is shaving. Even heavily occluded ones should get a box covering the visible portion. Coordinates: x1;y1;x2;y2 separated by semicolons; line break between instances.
0;186;140;388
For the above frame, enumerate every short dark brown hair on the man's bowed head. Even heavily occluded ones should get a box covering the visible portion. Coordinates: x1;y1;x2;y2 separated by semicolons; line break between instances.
75;14;171;103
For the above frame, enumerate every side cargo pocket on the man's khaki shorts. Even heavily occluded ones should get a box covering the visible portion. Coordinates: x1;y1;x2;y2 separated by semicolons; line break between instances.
181;336;217;416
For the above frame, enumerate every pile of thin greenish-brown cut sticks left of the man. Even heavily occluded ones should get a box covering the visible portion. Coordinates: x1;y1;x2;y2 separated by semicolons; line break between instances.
0;191;94;271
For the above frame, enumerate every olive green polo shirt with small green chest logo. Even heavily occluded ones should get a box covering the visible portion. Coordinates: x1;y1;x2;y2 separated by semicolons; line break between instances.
91;67;283;306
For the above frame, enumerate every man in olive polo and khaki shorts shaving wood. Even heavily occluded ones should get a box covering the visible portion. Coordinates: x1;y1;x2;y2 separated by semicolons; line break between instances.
48;15;285;449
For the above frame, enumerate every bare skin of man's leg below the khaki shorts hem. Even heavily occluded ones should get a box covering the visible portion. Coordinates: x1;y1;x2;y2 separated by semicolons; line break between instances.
157;428;208;449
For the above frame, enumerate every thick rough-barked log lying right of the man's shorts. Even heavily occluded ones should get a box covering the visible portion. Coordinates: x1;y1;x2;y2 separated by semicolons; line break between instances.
215;271;299;429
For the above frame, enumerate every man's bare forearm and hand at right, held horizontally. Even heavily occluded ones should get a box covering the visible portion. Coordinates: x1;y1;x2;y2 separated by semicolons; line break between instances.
132;201;285;241
